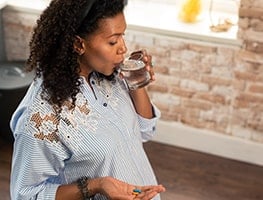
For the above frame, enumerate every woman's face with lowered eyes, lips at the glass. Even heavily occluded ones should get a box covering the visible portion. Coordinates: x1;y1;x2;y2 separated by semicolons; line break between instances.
79;13;127;76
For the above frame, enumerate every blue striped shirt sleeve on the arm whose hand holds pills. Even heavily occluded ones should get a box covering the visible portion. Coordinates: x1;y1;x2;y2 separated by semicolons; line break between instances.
10;134;69;200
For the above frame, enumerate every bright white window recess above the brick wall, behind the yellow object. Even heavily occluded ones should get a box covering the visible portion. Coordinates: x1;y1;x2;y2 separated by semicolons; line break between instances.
126;0;242;45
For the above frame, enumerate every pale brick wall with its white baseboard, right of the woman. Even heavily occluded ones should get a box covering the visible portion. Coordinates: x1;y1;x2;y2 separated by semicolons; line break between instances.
126;0;263;165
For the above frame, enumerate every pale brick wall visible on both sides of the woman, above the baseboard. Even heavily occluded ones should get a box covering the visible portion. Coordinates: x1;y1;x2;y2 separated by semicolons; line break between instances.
3;0;263;143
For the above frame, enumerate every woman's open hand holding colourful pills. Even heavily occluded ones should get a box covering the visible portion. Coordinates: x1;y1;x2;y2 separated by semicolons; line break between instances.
89;176;165;200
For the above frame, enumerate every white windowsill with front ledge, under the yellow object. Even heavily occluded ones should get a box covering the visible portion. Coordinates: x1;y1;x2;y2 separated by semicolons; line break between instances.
125;1;241;46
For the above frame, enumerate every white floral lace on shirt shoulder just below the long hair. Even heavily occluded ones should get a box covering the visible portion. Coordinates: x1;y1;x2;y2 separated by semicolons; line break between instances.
28;93;100;145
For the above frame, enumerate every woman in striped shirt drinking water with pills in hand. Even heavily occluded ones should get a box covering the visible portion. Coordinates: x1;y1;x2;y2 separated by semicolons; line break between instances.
11;0;165;200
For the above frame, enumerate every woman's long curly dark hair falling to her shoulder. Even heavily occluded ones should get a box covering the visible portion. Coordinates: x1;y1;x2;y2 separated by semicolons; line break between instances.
26;0;124;108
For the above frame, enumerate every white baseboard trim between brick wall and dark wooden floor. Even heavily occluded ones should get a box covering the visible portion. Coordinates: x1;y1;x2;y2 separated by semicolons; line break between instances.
153;120;263;166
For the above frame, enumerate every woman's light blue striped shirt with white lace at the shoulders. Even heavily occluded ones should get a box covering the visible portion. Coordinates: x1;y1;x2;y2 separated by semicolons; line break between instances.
10;74;160;200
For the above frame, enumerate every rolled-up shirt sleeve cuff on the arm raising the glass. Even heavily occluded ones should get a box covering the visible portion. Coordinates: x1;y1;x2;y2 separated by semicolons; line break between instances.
138;104;161;142
